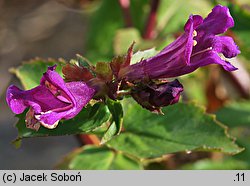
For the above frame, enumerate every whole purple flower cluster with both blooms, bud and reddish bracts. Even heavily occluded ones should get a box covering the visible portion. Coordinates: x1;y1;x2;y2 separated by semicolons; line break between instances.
6;5;240;130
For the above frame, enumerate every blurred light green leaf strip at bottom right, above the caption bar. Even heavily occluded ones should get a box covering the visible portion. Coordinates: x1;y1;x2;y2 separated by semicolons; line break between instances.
181;158;249;170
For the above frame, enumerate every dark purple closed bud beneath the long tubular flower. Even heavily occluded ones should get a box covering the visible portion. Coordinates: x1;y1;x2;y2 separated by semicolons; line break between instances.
131;79;183;113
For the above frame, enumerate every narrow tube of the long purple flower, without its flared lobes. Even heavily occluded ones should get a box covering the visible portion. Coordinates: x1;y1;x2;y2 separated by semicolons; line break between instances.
119;33;190;81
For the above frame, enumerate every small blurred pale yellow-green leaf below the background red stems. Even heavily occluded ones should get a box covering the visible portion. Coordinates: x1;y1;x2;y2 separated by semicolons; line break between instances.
114;28;142;55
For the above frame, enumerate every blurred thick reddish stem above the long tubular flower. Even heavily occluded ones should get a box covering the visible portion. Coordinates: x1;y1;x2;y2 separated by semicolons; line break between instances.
143;0;160;40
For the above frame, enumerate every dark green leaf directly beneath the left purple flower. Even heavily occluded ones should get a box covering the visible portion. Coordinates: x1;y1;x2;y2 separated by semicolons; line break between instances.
16;103;110;141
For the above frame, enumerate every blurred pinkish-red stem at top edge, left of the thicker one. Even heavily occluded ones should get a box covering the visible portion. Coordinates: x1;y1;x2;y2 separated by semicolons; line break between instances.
119;0;133;27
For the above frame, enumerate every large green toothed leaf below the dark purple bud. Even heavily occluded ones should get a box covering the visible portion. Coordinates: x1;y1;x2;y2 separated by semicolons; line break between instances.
107;103;243;158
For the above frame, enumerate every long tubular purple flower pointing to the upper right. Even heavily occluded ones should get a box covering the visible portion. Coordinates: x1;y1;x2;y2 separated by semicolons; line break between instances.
119;5;240;81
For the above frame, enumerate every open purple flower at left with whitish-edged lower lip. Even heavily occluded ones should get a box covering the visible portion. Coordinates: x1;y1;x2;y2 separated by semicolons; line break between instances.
6;66;95;130
